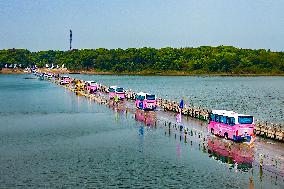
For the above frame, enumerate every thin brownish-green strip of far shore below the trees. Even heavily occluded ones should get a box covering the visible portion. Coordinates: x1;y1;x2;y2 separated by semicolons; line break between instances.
0;68;284;77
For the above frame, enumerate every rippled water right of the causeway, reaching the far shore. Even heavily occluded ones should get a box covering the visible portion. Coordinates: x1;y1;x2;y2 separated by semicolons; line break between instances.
73;74;284;124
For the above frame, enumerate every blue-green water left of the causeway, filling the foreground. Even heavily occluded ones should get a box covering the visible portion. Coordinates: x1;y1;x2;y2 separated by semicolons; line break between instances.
0;75;284;188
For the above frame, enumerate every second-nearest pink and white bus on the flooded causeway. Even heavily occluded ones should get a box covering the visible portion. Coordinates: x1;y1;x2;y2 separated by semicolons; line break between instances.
135;92;157;110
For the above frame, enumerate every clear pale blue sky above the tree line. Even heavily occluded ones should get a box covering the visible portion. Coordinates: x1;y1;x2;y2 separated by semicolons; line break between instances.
0;0;284;51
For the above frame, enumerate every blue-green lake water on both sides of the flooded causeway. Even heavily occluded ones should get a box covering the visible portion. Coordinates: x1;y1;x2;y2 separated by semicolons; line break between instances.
0;75;284;188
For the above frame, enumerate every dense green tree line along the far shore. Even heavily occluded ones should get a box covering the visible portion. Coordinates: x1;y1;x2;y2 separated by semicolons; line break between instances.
0;46;284;74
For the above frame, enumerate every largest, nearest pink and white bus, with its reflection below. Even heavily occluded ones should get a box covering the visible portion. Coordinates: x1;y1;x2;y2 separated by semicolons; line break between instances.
208;110;255;142
